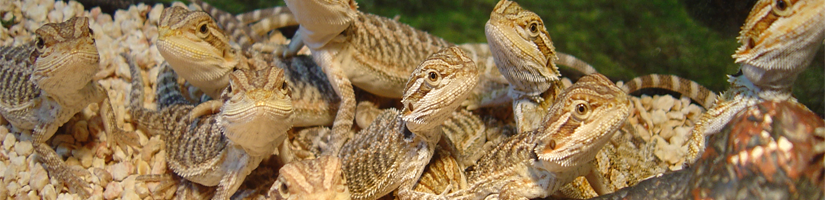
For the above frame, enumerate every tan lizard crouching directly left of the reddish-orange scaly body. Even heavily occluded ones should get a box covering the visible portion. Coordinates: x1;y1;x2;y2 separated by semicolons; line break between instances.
434;74;631;199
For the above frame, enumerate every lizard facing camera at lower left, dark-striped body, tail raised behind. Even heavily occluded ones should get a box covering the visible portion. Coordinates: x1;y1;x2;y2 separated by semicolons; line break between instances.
130;53;292;199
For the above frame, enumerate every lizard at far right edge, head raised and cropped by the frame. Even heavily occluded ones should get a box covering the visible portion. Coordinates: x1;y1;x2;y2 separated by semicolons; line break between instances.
688;0;825;161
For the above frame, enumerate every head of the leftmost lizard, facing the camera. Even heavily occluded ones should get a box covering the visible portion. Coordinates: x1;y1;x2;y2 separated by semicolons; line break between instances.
30;17;100;92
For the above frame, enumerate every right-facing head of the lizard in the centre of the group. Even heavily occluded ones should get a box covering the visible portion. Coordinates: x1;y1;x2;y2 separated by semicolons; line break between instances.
401;47;479;139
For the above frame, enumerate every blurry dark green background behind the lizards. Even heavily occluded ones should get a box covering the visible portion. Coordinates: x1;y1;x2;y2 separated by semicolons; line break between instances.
148;0;825;116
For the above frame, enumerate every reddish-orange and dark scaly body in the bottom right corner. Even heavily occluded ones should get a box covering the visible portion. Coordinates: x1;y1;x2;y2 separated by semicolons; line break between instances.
595;101;825;199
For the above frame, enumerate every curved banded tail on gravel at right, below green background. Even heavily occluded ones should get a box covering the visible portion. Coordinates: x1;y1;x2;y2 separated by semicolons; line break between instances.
622;74;716;108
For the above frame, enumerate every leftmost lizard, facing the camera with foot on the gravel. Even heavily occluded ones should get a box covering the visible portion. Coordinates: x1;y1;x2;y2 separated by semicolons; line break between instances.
0;17;106;197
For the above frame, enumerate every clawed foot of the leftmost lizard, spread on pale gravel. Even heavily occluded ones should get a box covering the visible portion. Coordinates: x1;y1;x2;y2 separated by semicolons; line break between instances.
35;143;92;198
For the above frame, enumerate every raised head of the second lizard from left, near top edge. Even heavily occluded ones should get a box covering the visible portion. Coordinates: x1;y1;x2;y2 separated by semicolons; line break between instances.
156;6;242;98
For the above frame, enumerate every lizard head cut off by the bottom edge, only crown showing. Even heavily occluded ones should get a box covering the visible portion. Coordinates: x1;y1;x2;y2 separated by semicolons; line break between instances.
269;156;350;200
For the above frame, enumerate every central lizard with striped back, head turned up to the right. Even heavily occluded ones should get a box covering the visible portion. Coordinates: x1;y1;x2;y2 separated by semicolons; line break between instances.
339;47;478;199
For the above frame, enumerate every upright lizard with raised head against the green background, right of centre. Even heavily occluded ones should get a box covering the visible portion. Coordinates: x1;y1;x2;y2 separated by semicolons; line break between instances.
484;0;563;132
